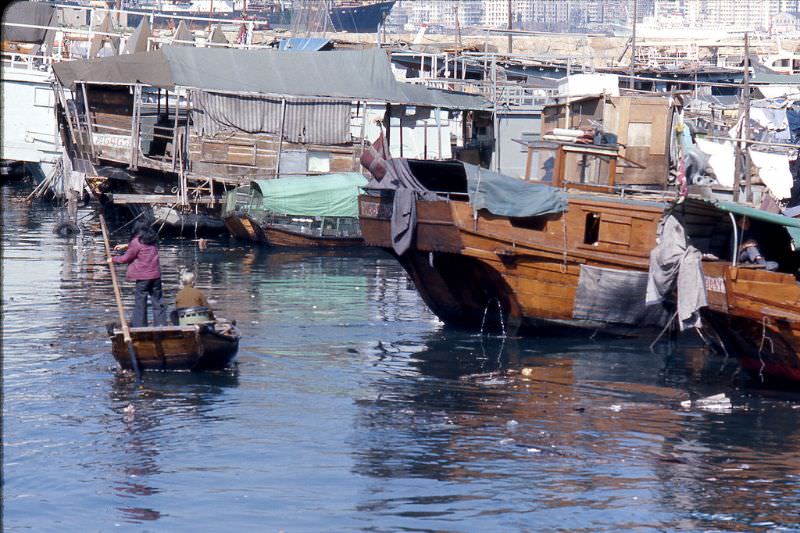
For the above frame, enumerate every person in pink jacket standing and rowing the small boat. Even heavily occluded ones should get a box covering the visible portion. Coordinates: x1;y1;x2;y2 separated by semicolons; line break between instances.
113;220;167;328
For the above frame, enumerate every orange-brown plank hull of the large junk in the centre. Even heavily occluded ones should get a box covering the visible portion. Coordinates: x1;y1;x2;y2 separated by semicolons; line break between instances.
359;189;663;335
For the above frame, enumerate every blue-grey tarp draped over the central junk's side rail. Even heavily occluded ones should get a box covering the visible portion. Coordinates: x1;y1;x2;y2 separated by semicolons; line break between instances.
463;163;567;217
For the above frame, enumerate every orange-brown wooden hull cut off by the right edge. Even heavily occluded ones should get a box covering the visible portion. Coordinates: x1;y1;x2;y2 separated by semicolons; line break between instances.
703;263;800;383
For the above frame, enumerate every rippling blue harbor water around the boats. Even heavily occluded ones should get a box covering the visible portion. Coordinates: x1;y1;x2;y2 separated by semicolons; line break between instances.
2;181;800;532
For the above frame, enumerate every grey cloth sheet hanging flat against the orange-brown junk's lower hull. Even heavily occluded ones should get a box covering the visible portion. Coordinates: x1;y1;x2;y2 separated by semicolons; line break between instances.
572;265;669;326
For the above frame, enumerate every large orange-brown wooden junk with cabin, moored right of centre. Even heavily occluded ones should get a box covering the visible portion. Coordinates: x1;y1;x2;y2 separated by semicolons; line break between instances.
359;92;672;333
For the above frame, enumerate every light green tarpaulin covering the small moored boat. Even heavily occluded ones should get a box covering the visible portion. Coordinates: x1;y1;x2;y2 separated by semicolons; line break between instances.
250;172;367;217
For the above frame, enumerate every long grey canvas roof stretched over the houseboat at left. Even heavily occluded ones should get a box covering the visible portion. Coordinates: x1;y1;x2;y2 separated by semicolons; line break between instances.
54;46;488;109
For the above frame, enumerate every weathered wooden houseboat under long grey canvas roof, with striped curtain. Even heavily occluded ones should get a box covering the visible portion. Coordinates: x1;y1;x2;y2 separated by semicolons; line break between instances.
50;46;485;232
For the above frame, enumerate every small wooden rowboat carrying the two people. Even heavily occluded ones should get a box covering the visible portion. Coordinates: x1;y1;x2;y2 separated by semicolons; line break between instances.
111;325;239;371
